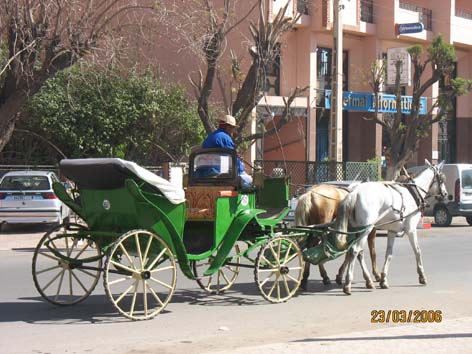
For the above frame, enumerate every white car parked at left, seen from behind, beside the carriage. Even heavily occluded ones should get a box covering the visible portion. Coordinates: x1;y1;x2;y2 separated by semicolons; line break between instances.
0;171;70;227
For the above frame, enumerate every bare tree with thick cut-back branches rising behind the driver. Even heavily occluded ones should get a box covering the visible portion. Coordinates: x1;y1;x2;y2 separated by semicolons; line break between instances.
162;0;300;144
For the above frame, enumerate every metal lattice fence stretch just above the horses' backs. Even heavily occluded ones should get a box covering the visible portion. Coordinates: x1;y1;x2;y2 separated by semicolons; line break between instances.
255;160;380;195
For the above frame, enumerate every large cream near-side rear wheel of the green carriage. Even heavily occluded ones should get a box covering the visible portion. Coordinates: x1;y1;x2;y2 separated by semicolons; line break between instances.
103;230;177;320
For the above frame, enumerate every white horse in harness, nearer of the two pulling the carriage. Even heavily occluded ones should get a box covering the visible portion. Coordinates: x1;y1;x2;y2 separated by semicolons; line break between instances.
333;160;447;295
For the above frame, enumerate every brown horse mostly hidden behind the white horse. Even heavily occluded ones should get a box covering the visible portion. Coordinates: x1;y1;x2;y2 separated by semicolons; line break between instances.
295;184;380;290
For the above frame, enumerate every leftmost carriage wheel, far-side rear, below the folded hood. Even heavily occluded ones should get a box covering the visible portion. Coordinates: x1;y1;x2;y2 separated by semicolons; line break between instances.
32;224;102;305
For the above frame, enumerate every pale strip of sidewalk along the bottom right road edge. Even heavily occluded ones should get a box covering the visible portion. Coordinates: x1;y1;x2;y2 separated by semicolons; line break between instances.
204;317;472;354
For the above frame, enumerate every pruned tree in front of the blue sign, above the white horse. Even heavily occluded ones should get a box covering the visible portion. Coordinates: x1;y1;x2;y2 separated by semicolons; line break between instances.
366;36;472;179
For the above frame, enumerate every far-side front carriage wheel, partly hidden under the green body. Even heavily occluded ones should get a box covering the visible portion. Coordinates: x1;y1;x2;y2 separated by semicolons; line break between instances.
193;244;240;294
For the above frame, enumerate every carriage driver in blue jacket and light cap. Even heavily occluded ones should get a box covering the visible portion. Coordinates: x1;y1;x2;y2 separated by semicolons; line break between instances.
202;114;252;186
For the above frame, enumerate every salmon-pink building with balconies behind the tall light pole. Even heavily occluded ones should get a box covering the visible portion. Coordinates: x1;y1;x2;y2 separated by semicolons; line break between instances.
257;0;472;164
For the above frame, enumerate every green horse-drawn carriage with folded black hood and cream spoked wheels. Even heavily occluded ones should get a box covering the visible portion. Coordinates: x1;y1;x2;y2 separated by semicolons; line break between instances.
33;149;309;320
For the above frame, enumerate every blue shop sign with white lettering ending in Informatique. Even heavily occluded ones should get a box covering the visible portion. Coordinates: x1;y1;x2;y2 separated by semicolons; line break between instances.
325;90;428;115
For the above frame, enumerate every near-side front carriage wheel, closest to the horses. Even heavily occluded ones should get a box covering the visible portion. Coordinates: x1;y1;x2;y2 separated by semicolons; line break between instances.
254;237;303;303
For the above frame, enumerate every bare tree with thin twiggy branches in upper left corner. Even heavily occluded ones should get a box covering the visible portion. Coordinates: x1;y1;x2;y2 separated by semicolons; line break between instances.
0;0;159;151
